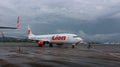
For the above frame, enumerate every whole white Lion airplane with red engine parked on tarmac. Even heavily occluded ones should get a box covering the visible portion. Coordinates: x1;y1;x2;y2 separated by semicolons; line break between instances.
28;25;83;48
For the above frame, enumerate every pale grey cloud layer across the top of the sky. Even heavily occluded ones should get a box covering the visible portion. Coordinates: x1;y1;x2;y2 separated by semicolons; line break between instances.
0;0;120;23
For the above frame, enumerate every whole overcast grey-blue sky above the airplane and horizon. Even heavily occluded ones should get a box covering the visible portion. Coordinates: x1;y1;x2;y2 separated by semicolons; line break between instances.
0;0;120;41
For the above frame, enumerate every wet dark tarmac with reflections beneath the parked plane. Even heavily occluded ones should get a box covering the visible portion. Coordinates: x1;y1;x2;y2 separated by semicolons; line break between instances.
0;43;120;67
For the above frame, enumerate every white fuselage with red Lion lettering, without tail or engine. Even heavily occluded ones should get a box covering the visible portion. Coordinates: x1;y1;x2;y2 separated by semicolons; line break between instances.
28;34;83;44
